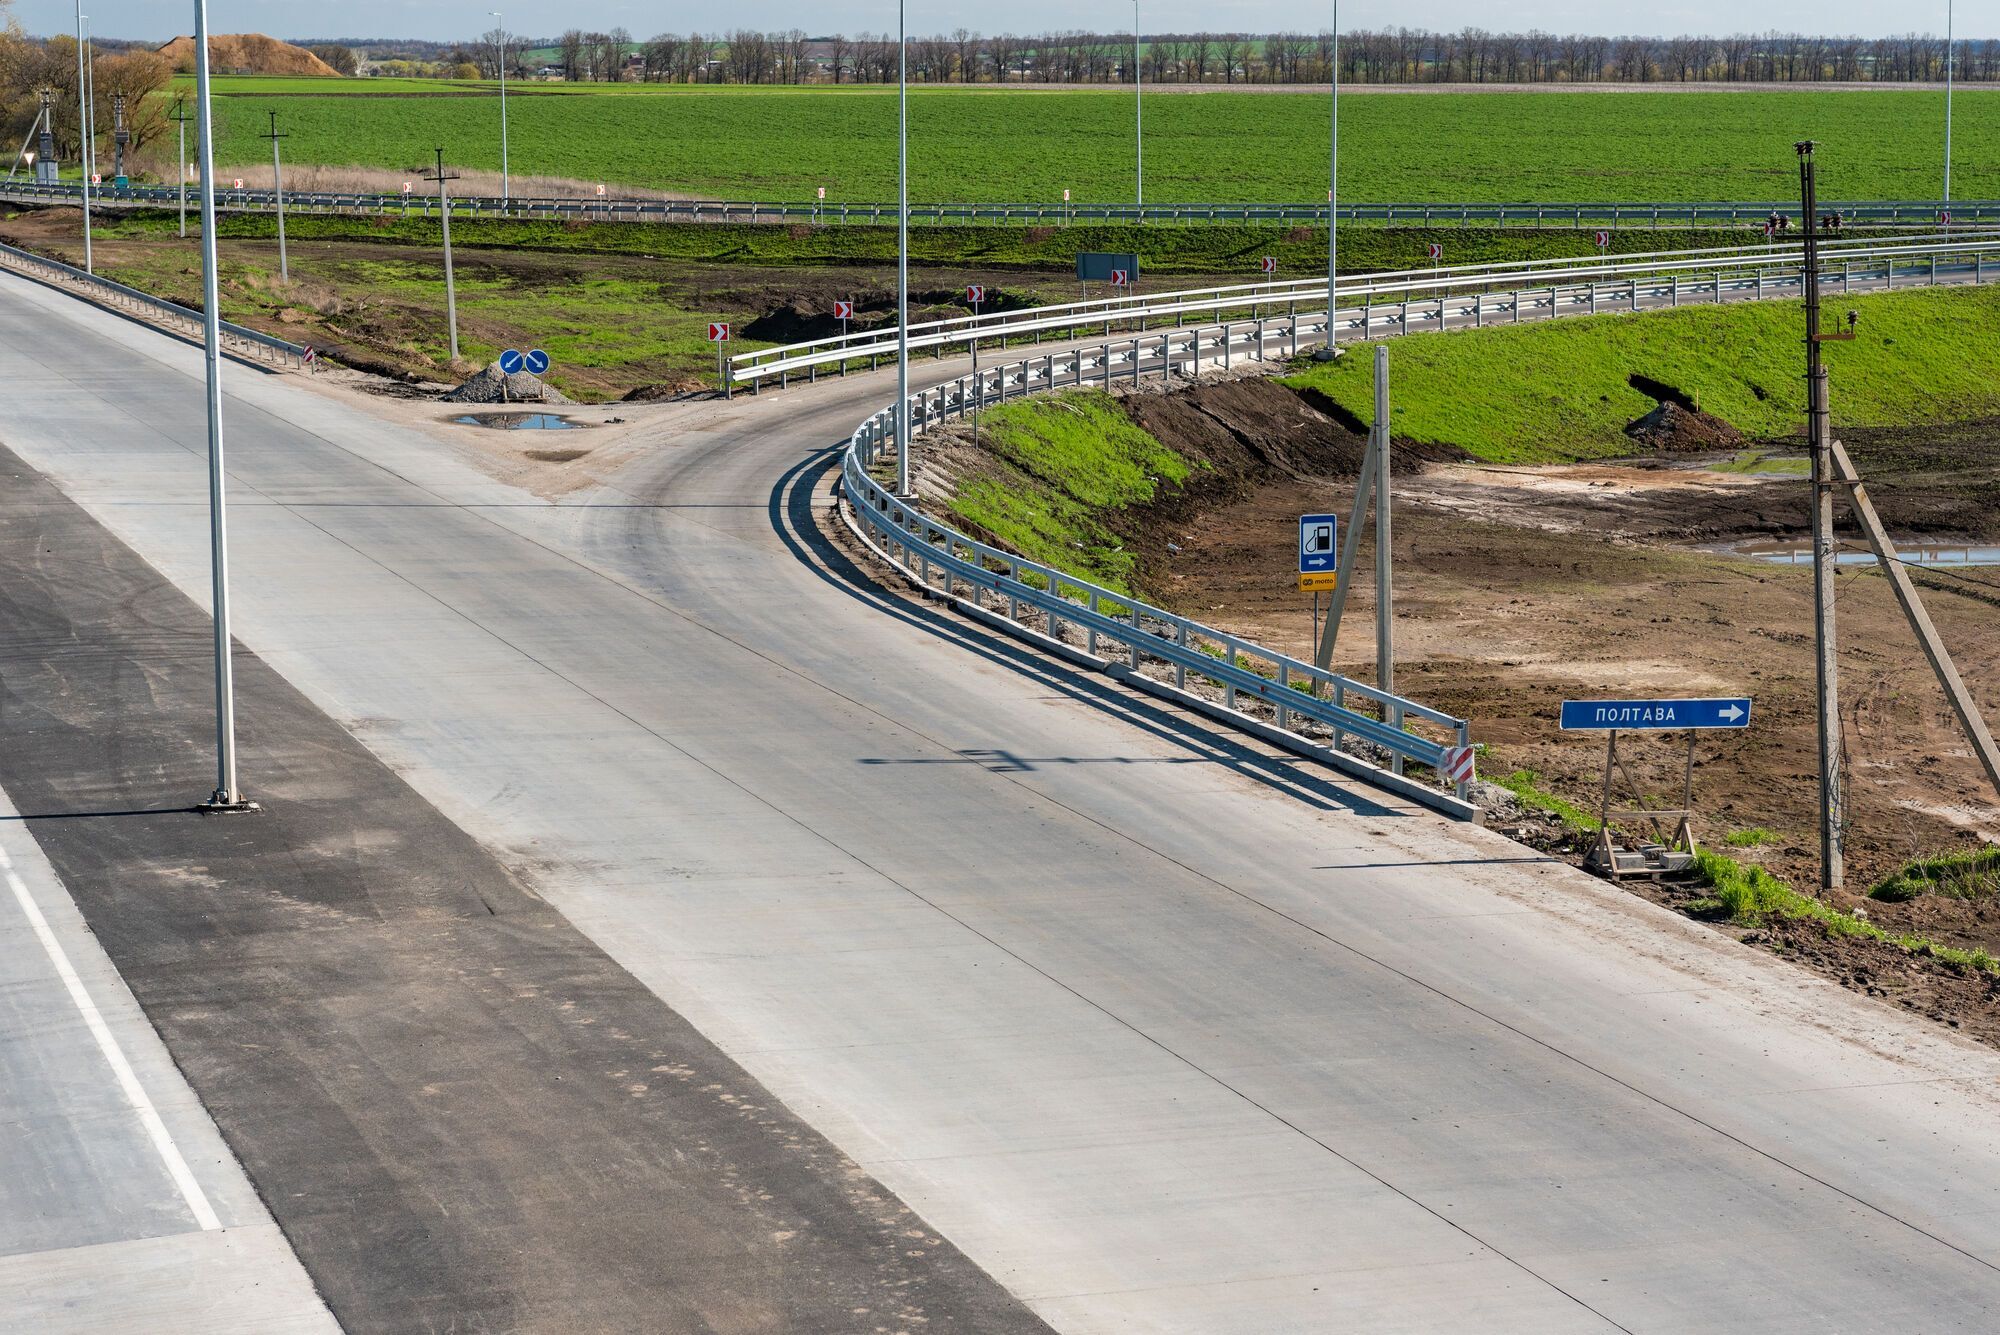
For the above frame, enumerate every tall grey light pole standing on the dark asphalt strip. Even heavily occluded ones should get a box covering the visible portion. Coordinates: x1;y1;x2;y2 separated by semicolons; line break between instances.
194;0;256;811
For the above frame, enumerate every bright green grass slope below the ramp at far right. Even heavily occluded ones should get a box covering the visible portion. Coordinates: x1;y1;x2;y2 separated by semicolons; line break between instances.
1286;288;2000;464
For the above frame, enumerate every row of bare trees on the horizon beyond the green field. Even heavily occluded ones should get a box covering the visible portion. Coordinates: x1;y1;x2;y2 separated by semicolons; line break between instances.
488;28;2000;86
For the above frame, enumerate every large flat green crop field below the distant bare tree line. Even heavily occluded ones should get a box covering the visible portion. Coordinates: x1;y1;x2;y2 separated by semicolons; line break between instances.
168;78;2000;202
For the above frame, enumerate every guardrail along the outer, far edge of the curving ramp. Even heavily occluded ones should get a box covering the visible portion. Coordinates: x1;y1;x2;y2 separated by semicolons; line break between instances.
728;234;2000;392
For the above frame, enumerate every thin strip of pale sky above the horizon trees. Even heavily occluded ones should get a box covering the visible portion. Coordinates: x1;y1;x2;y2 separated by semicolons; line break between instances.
14;0;2000;42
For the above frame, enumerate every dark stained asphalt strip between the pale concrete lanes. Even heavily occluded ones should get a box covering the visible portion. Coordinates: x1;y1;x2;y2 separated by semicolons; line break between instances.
0;450;1046;1333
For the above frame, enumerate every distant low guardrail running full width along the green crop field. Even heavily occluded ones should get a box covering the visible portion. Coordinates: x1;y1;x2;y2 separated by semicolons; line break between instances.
0;182;2000;228
